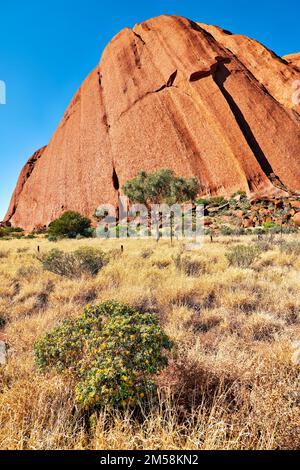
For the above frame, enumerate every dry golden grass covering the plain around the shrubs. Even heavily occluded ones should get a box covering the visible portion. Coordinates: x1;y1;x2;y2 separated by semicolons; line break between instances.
0;236;300;449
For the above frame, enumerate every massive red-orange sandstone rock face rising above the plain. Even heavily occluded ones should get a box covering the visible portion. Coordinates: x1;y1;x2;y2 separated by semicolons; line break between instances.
6;16;300;229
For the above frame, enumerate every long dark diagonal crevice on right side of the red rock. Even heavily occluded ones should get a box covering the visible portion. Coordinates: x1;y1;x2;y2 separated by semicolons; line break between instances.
213;62;274;177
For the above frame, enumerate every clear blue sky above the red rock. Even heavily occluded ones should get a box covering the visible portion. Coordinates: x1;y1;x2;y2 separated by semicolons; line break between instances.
0;0;300;220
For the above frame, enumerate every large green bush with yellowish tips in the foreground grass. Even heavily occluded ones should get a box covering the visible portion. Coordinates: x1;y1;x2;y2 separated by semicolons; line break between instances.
34;301;172;410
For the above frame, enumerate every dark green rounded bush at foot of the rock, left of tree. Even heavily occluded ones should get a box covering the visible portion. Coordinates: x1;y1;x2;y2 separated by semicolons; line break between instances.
48;211;91;238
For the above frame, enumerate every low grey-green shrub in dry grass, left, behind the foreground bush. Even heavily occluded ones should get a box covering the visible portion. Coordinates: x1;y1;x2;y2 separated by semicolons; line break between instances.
38;247;108;278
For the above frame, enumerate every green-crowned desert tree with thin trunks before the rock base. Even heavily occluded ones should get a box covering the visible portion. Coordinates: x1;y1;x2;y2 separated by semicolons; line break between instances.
123;168;200;240
